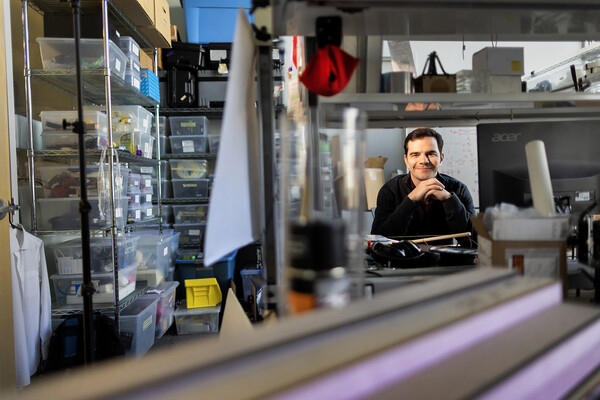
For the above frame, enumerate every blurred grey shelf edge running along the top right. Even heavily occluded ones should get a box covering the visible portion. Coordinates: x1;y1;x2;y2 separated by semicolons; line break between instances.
272;0;600;41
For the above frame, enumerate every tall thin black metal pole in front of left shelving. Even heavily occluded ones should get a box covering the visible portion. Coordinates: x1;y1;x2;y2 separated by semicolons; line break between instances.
71;0;94;364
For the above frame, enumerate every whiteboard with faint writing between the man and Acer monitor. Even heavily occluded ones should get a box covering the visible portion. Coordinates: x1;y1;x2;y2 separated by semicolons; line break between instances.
435;126;479;208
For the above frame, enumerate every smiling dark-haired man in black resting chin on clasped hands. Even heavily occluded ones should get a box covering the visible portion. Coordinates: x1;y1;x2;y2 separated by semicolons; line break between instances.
371;128;475;244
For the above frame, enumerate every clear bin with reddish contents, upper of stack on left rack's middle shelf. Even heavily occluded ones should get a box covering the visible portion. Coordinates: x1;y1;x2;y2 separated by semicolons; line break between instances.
37;165;129;198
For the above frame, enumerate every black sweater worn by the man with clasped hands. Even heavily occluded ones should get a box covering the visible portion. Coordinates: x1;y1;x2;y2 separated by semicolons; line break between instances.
371;174;475;244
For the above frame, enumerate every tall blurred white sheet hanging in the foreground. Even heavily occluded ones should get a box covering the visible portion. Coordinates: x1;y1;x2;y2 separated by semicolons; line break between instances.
204;8;261;265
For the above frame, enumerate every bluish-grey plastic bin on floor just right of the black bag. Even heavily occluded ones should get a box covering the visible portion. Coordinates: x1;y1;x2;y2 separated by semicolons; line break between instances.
119;296;158;357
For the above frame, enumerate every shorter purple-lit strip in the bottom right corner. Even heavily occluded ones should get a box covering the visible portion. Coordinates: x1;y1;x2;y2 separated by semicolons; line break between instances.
480;320;600;400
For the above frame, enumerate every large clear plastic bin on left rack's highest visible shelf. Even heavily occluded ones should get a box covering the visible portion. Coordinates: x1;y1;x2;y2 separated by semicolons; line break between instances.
36;37;127;79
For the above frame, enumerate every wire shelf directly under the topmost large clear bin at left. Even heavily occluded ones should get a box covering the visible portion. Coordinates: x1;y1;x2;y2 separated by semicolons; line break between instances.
31;69;157;107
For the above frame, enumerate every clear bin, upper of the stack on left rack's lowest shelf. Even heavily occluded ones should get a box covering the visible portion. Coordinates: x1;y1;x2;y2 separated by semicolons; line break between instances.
54;236;138;275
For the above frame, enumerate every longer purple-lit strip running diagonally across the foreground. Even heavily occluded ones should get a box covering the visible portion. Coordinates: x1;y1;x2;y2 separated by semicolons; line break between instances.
273;283;562;400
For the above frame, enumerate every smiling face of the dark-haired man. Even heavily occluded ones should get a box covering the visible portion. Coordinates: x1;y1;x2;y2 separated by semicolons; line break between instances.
404;137;444;183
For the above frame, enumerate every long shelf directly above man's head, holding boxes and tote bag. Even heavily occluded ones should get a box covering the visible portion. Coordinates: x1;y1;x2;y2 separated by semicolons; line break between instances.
320;92;600;128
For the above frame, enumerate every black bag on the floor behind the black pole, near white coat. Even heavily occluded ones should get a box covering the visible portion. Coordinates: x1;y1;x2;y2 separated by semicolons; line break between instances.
44;312;125;372
